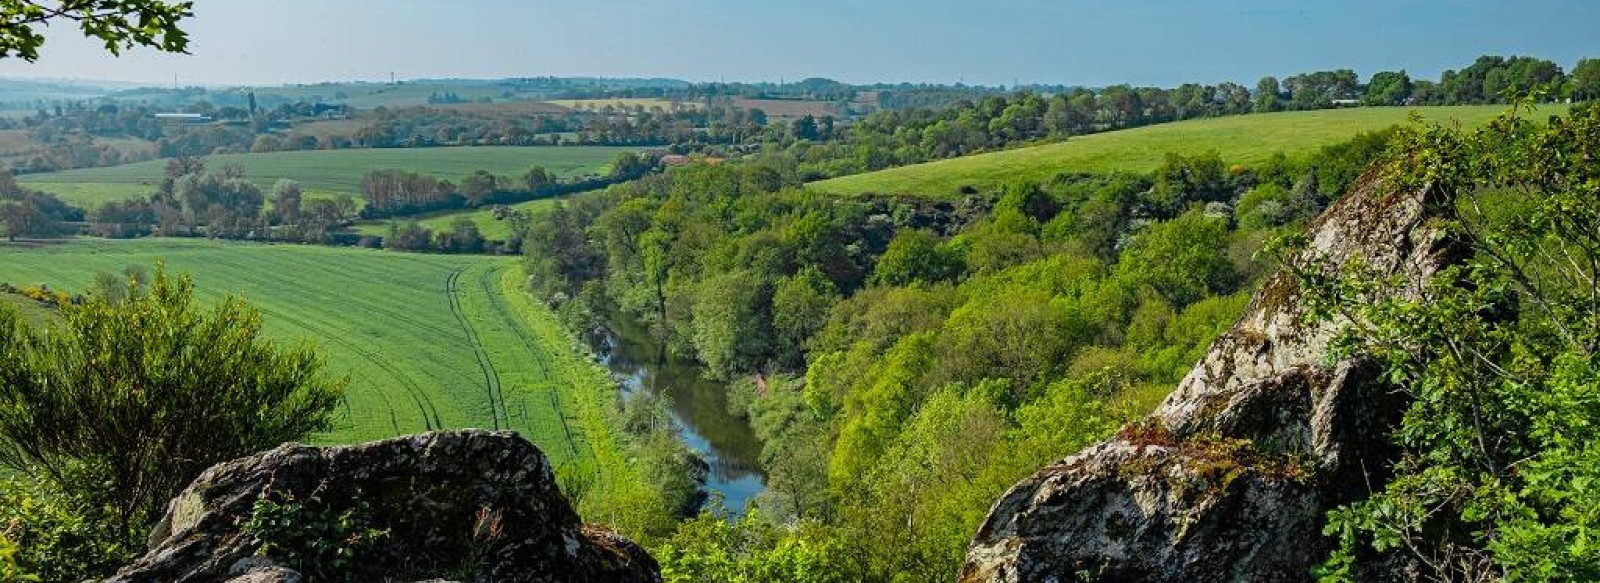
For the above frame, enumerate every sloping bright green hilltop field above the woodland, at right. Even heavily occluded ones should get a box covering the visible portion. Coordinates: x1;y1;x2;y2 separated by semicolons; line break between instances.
810;106;1565;195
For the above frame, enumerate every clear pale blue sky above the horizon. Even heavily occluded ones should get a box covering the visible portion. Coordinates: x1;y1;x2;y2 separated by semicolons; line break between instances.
0;0;1600;86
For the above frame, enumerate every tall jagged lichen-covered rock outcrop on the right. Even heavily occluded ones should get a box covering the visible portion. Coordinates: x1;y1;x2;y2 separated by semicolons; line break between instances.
962;175;1456;581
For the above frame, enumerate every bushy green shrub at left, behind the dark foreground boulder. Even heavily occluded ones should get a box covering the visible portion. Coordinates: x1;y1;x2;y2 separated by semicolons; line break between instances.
0;269;344;540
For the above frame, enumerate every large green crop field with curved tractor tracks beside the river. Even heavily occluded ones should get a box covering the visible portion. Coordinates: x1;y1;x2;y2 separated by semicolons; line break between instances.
0;239;619;477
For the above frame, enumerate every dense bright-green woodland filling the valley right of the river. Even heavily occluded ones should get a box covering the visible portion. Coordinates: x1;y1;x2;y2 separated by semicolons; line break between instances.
525;120;1386;580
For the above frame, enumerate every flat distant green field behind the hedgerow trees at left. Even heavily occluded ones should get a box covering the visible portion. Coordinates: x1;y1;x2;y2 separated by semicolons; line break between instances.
19;146;630;207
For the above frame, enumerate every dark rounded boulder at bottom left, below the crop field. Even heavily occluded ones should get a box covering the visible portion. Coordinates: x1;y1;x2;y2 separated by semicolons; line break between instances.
109;431;661;583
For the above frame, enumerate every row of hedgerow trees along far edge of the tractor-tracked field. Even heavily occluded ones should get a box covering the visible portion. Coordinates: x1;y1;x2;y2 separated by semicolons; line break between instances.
73;152;654;253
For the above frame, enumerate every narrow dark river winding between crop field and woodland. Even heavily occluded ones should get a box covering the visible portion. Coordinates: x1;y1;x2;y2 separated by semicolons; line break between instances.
589;316;766;514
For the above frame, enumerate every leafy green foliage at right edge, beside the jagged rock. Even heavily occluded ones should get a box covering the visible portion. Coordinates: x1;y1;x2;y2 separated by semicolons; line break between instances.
1298;107;1600;581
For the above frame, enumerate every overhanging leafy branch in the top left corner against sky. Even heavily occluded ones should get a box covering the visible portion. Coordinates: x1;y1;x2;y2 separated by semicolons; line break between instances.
0;0;194;61
